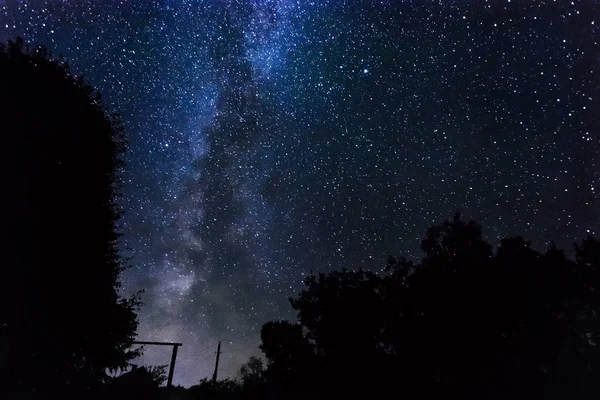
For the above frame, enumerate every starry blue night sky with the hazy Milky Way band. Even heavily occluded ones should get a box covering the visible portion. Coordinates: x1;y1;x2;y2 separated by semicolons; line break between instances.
0;0;600;386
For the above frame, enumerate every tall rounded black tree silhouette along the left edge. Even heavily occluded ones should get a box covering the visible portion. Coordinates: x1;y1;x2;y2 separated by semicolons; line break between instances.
0;39;139;393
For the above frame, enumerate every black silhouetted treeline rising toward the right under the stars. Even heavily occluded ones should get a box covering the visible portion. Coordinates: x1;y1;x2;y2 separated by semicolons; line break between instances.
188;215;600;399
